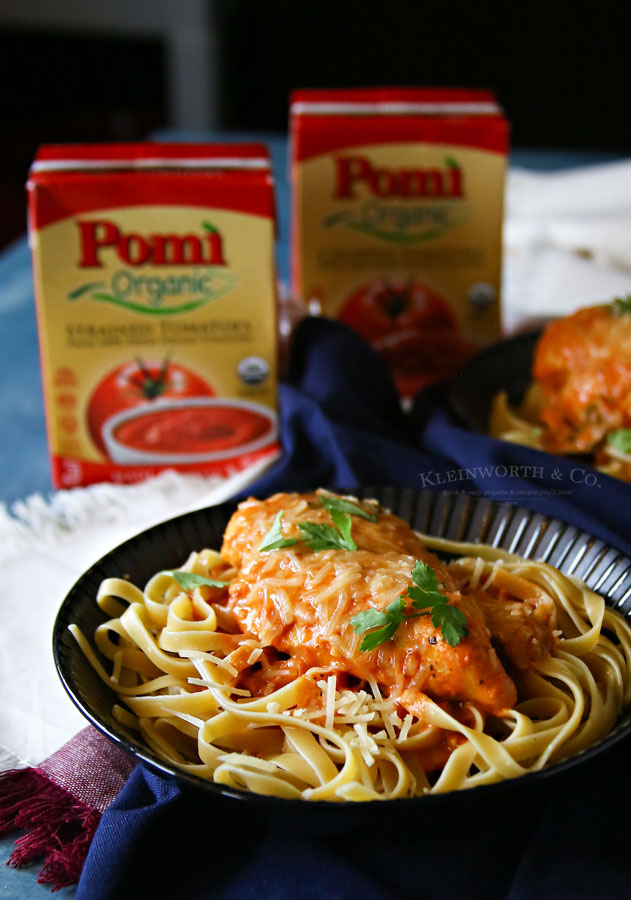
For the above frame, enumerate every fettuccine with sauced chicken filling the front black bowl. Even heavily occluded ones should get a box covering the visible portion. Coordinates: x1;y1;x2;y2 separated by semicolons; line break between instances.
71;495;631;801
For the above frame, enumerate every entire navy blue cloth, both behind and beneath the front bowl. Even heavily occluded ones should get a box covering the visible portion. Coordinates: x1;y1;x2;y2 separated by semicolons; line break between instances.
77;320;631;900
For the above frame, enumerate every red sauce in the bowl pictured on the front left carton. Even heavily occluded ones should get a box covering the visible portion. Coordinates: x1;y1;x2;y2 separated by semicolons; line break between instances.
114;406;271;453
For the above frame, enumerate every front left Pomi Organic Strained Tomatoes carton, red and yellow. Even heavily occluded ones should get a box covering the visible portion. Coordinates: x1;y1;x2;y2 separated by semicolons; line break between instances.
27;144;278;487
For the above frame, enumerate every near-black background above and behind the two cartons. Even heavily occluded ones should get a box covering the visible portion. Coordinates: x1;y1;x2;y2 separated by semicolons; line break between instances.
0;0;631;246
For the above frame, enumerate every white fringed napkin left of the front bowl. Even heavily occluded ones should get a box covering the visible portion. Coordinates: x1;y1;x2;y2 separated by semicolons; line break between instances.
0;459;271;771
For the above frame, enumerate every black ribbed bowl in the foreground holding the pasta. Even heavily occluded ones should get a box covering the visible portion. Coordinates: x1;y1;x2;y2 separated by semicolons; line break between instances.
53;487;631;831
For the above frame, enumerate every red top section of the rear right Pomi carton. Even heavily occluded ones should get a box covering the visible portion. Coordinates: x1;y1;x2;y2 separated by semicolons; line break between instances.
290;88;508;162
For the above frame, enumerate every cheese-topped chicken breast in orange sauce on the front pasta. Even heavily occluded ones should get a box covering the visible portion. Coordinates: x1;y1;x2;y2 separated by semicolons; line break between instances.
222;494;517;714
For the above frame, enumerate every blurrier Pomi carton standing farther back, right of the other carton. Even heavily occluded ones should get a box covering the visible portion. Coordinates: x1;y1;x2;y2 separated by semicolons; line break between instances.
290;88;508;397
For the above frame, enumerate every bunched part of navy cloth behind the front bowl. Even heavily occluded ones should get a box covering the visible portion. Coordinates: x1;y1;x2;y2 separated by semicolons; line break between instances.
258;319;631;554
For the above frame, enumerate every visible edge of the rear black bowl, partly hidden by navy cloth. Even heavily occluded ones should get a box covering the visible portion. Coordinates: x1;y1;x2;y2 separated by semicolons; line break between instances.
447;331;541;434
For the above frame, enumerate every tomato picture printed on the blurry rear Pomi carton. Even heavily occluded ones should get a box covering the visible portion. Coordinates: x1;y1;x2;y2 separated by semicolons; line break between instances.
338;278;478;397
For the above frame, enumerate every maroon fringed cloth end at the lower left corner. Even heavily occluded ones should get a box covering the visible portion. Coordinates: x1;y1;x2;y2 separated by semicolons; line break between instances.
0;727;135;891
